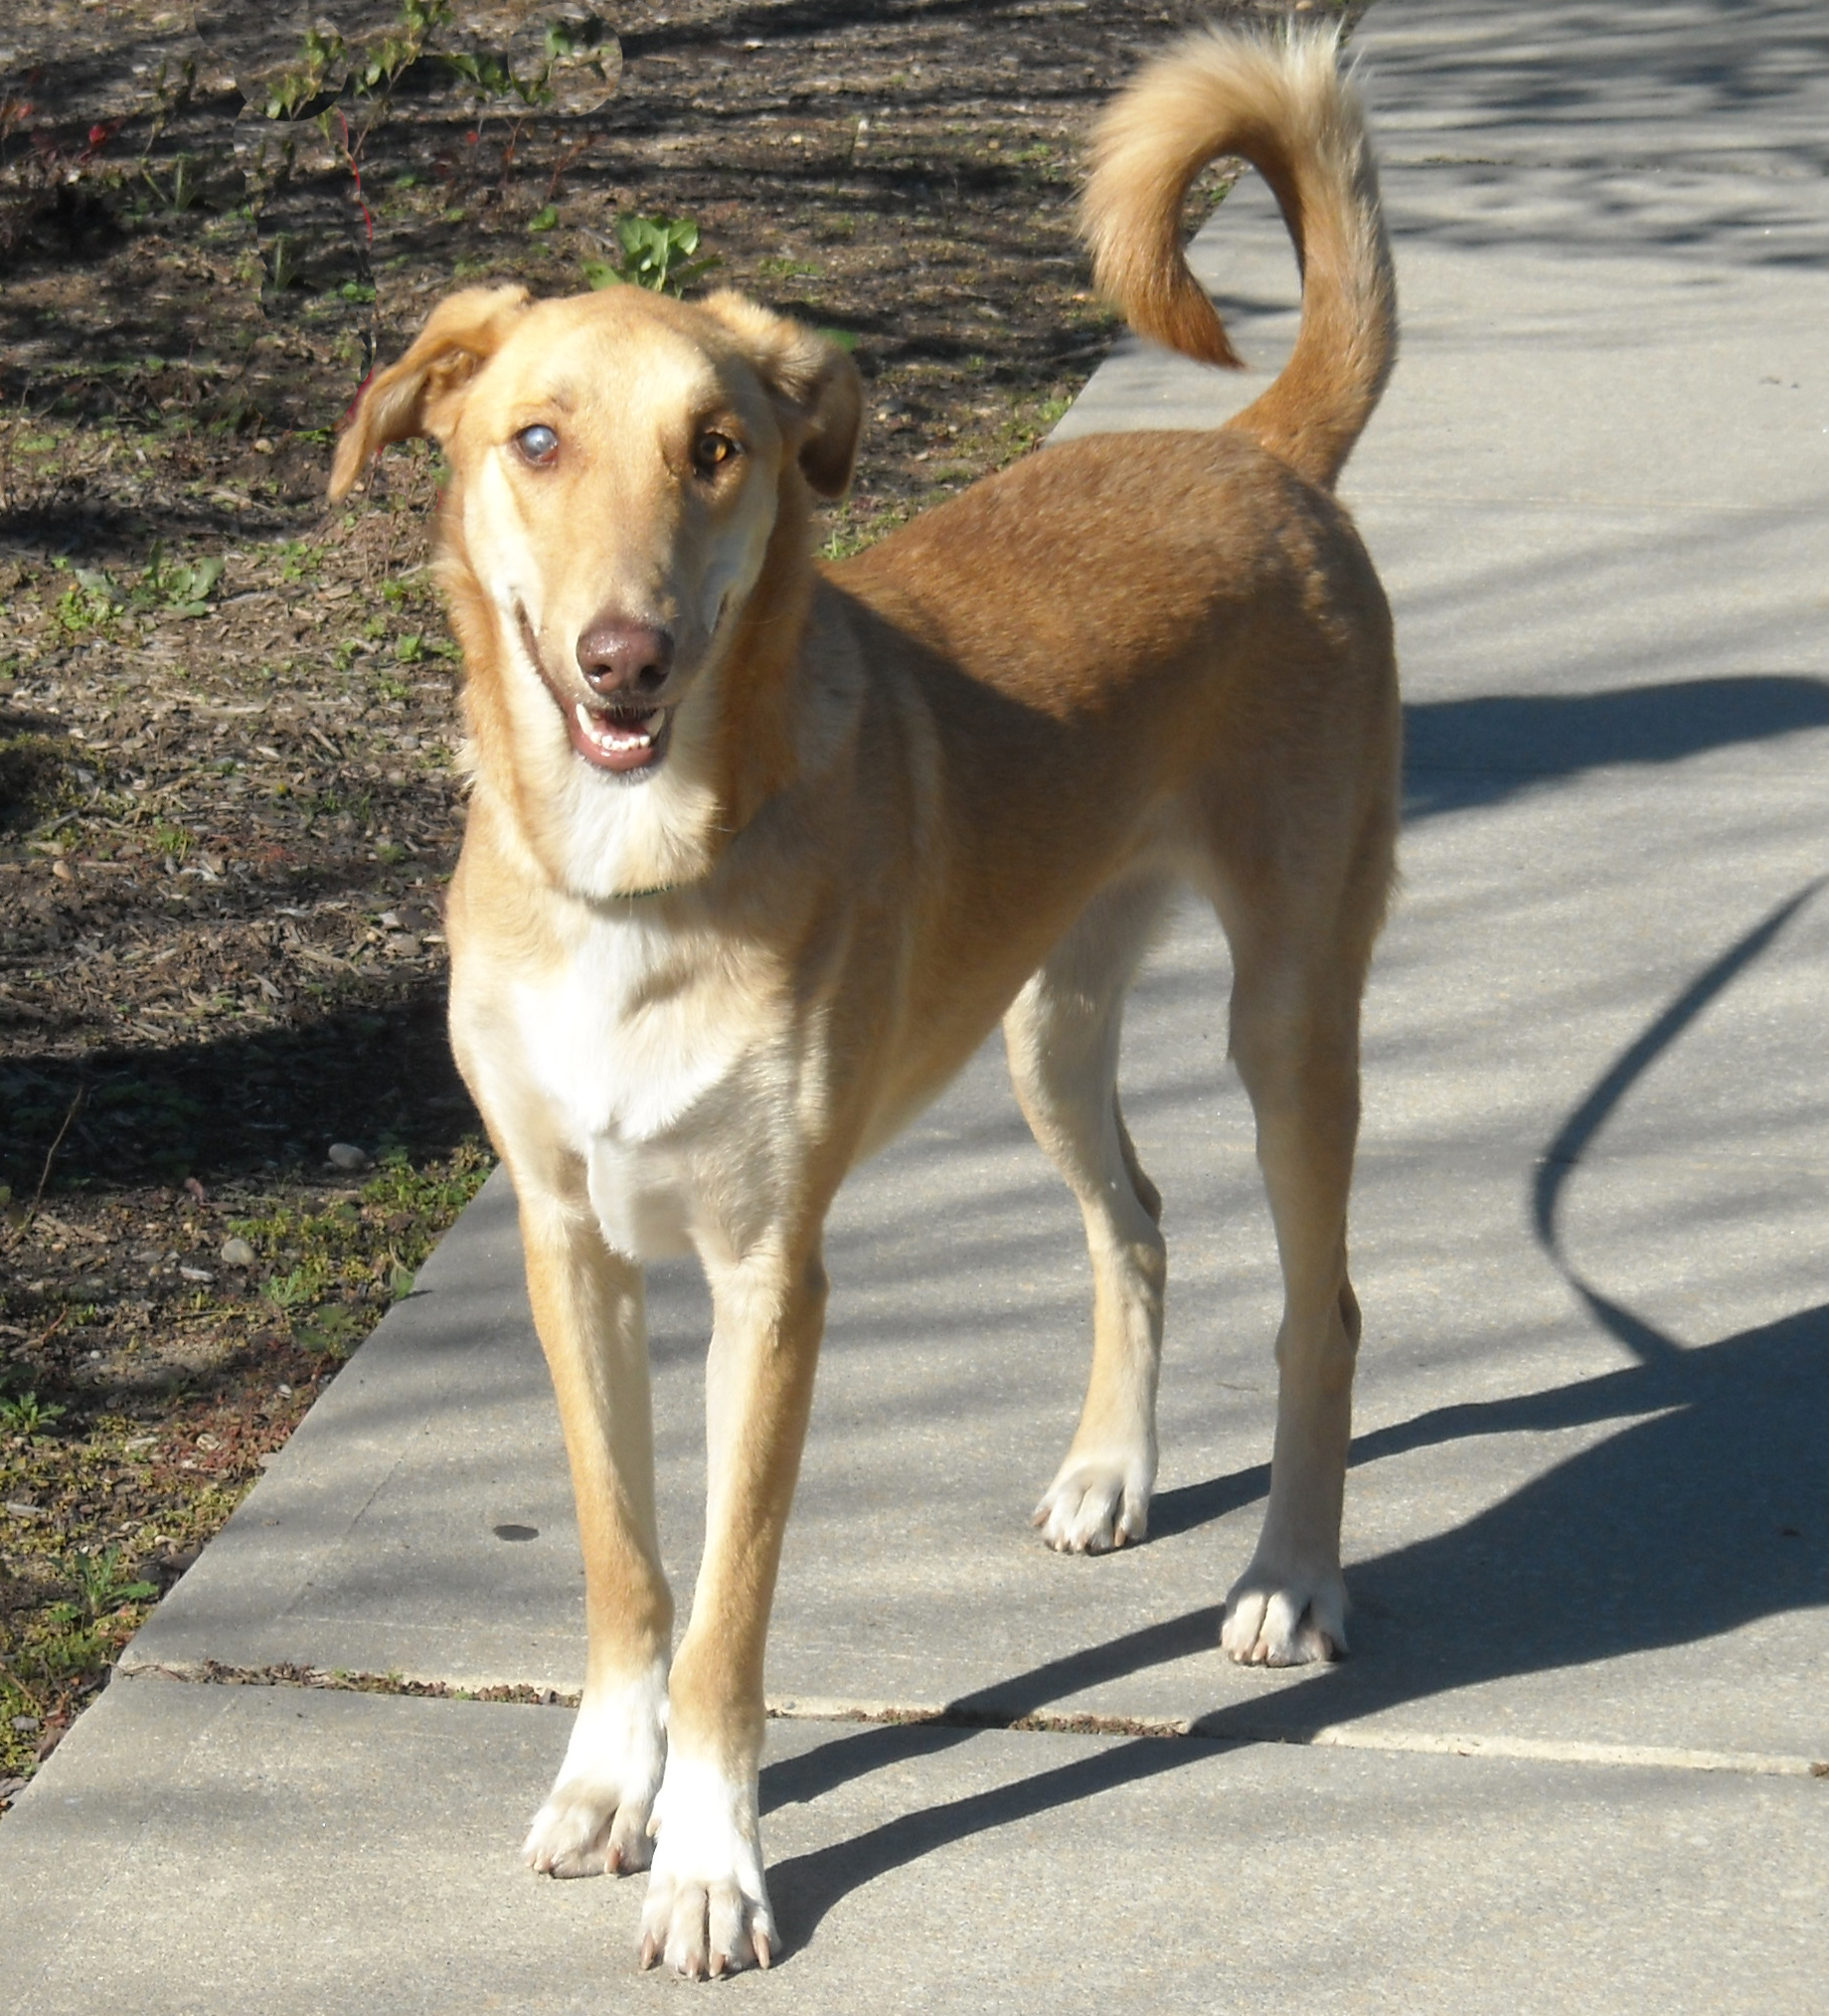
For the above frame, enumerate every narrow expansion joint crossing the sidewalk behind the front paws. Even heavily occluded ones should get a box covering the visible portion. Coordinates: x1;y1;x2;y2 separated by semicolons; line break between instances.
117;1659;1829;1782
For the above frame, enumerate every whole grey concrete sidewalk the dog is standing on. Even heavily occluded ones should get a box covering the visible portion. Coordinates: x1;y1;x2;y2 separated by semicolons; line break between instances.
0;0;1829;2016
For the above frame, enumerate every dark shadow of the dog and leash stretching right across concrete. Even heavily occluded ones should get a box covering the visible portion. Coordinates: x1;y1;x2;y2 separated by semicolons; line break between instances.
762;883;1829;1949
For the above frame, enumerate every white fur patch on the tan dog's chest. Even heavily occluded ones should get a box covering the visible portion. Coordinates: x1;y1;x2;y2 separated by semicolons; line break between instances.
512;910;794;1260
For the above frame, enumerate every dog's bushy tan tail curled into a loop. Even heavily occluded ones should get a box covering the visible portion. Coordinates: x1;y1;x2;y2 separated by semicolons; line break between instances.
1082;28;1398;488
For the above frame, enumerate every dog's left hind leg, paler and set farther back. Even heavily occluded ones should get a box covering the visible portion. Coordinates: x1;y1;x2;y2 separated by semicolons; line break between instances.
1004;879;1170;1555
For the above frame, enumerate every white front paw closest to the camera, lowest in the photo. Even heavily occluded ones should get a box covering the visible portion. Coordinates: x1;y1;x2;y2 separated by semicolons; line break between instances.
641;1752;780;1982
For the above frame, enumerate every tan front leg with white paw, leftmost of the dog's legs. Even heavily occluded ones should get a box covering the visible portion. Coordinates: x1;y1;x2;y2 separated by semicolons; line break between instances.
514;1167;674;1877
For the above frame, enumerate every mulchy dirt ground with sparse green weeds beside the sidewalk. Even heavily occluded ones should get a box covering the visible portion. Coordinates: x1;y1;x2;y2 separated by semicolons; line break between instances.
0;0;1327;1808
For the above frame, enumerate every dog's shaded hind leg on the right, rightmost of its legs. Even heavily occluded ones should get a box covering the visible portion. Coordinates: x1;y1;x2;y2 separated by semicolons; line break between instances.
1220;842;1384;1665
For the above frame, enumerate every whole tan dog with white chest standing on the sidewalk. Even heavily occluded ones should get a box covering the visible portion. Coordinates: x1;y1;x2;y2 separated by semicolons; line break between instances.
331;32;1398;1975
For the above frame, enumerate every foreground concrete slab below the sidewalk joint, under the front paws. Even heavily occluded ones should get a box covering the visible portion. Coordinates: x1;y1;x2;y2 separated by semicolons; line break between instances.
0;1681;1829;2016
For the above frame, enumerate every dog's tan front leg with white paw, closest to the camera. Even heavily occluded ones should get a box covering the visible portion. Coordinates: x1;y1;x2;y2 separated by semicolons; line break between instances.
641;1240;825;1979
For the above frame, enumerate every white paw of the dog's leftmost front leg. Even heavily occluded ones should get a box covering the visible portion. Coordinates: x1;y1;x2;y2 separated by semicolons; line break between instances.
520;1665;667;1877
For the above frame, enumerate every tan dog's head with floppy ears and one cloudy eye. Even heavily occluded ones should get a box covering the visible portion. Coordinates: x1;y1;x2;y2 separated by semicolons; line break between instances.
331;286;861;895
